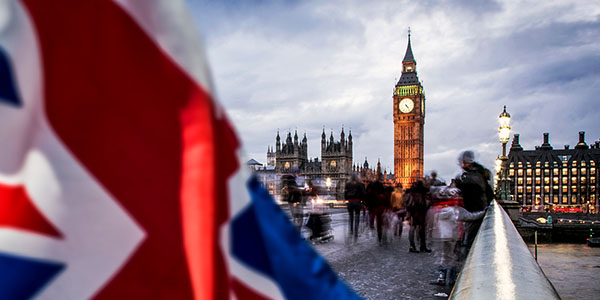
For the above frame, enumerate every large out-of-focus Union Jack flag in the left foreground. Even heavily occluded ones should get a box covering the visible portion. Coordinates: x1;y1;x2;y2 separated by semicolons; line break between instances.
0;0;357;299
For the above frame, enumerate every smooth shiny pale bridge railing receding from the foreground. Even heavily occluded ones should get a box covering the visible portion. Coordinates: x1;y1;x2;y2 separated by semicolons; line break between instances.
449;201;560;300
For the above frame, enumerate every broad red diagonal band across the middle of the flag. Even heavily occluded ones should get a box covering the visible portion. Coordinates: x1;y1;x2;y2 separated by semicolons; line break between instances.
25;0;238;299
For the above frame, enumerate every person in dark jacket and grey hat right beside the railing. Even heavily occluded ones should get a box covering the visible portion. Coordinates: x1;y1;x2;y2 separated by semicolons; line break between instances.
454;150;494;253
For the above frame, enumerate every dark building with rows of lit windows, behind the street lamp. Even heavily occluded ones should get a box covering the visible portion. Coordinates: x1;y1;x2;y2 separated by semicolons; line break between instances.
506;131;600;213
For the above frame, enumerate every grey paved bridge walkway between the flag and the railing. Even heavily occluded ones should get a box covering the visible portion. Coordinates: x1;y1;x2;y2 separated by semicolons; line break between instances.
315;214;451;300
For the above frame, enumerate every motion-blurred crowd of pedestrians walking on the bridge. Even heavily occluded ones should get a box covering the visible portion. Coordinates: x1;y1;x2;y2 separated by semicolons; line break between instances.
282;151;494;285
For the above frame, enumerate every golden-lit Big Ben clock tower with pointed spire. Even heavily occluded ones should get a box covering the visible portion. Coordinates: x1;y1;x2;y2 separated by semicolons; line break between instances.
393;29;425;188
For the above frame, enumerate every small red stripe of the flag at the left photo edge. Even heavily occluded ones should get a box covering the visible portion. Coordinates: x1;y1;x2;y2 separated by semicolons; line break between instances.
0;183;62;238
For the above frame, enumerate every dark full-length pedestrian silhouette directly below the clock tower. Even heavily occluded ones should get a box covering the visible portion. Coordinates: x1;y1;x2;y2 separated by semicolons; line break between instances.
406;180;431;253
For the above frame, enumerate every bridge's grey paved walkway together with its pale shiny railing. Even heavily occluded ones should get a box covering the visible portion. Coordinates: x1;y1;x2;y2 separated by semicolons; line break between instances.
296;204;560;300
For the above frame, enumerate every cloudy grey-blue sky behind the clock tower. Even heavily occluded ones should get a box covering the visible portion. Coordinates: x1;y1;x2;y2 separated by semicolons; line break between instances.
188;0;600;182
